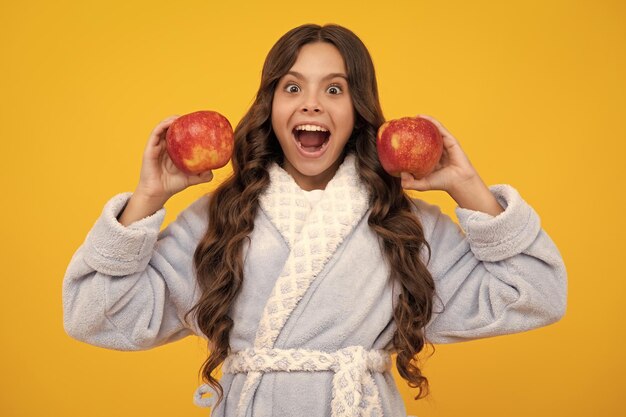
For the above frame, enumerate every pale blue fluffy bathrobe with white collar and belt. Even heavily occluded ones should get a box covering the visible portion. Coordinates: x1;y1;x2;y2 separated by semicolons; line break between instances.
63;155;567;417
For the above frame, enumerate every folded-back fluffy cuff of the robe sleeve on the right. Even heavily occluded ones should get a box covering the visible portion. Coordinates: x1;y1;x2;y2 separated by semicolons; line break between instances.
455;184;541;262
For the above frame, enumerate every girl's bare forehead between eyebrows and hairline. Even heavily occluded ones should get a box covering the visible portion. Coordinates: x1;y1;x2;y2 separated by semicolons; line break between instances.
290;42;346;75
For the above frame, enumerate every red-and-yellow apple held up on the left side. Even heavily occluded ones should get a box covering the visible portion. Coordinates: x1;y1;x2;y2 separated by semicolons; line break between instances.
165;110;234;175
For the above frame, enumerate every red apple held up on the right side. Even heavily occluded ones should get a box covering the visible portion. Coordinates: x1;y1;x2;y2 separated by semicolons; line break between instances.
376;117;443;179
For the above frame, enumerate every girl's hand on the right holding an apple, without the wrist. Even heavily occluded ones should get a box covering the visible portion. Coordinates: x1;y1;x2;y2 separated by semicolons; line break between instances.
401;114;479;194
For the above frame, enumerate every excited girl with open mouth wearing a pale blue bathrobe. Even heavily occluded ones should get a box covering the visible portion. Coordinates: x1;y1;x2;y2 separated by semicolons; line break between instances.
63;25;566;417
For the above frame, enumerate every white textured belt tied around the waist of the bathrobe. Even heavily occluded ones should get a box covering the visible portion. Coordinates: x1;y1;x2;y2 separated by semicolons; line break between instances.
195;346;391;417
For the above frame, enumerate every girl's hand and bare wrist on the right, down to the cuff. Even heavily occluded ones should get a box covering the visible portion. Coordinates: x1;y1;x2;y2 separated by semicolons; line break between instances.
400;114;504;216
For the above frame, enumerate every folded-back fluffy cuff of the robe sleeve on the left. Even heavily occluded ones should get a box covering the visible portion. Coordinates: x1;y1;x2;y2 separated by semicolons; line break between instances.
85;193;165;276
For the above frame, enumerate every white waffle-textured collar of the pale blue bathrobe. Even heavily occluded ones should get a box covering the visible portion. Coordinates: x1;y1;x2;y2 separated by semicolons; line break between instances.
254;155;369;348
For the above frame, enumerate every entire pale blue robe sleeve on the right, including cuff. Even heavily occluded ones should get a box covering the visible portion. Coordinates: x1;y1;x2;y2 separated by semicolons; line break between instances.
416;185;567;343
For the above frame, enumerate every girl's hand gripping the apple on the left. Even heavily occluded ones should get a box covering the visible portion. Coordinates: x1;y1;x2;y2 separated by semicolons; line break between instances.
135;116;213;203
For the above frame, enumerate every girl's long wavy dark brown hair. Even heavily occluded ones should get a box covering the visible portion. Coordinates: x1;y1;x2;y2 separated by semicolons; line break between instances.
185;24;434;403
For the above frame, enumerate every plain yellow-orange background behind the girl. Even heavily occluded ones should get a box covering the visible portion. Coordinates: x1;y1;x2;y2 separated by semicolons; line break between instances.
0;0;626;417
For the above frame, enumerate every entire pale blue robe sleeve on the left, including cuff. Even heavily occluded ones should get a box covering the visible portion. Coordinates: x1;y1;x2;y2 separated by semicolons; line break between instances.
63;193;208;350
